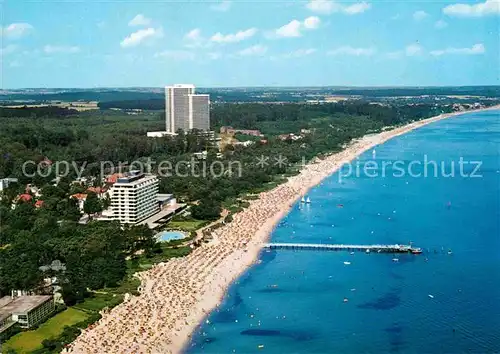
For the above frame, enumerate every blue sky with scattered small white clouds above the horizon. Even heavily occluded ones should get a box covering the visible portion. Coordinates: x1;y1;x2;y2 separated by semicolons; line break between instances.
0;0;500;89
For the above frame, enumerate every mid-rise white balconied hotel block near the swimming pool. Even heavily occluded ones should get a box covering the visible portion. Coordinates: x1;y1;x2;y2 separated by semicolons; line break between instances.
109;171;159;224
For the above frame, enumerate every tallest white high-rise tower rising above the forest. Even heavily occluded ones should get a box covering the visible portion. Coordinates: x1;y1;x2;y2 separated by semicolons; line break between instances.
148;84;210;137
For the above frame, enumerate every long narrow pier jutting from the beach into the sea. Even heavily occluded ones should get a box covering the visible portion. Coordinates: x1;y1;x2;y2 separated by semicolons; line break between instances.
264;243;422;254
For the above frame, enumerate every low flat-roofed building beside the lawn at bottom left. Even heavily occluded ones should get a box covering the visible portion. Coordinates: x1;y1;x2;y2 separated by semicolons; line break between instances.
0;295;55;333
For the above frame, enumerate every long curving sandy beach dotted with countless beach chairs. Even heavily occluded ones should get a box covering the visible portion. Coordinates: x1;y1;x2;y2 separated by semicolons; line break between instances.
64;105;500;353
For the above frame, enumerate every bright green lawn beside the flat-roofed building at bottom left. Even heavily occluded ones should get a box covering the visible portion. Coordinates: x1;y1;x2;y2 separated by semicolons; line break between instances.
3;308;89;353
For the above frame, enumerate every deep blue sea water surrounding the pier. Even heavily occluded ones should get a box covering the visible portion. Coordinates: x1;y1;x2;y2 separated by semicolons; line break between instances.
185;111;500;353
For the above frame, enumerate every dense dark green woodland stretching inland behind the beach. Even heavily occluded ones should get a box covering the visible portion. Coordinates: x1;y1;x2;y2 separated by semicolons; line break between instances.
0;101;486;304
